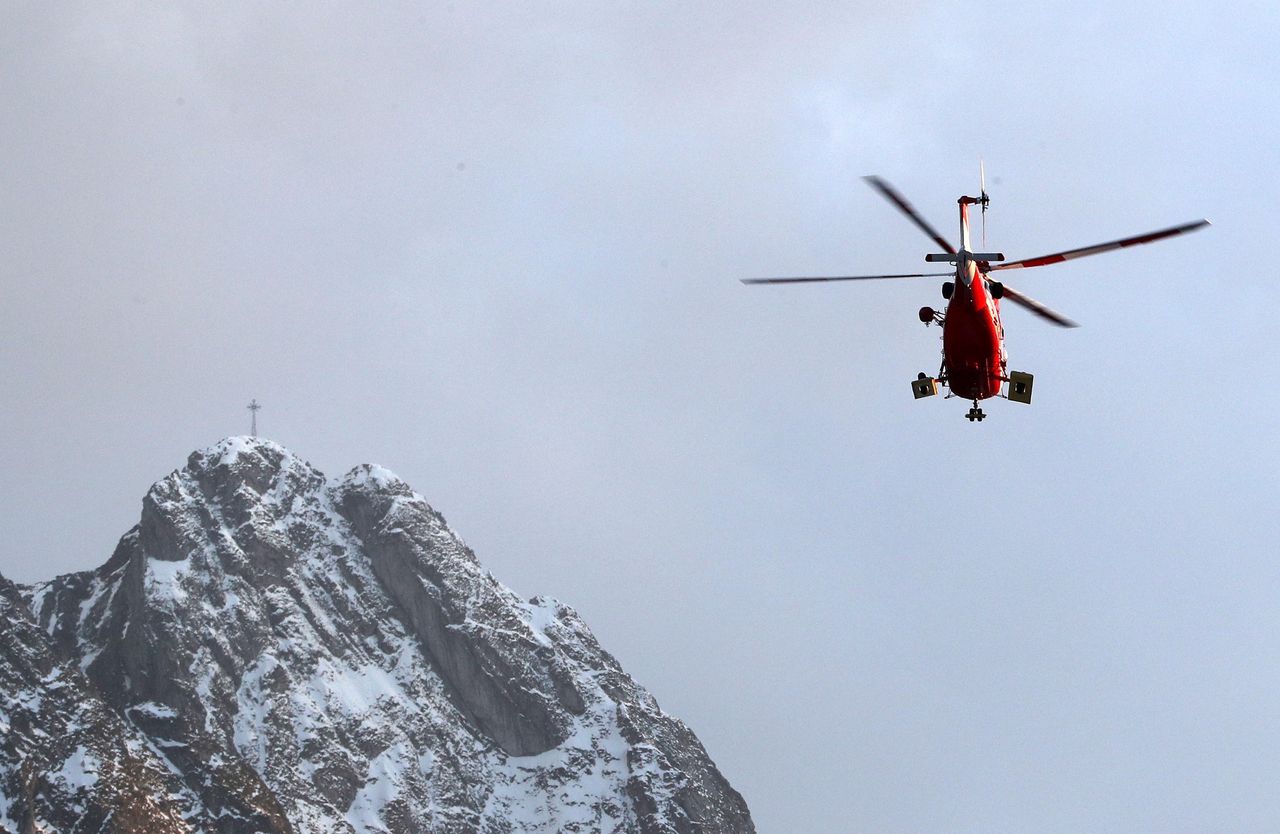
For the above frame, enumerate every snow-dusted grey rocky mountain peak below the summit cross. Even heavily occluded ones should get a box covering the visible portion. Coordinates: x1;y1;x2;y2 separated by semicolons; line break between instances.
0;437;754;834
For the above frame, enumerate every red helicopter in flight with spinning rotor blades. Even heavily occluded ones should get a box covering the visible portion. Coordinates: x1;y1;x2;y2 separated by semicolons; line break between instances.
742;171;1208;422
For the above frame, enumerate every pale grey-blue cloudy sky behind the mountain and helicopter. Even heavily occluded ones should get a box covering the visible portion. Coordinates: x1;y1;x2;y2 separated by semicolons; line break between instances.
0;0;1280;834
